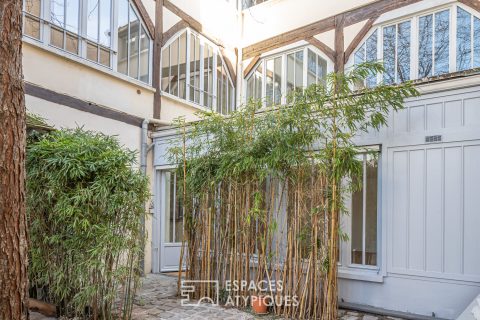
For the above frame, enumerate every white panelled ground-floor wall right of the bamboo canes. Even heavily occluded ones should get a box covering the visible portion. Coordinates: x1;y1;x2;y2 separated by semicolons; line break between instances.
340;82;480;319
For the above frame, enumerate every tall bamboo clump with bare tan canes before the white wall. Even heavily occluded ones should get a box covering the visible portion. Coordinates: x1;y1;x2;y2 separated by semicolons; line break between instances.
171;63;418;319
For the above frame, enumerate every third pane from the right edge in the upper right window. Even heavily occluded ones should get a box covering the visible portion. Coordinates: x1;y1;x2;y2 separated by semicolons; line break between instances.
434;10;450;75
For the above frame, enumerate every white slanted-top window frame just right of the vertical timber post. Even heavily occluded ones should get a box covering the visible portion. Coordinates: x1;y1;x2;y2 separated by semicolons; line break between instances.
160;28;236;114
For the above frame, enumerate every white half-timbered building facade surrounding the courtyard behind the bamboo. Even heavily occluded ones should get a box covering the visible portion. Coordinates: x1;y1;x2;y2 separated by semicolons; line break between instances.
24;0;480;319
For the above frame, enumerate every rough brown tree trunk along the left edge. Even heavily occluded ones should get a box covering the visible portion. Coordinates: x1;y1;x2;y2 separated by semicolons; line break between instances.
0;0;28;320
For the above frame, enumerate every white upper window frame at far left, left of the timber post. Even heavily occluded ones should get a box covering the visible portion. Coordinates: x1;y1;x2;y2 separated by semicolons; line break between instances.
22;0;153;87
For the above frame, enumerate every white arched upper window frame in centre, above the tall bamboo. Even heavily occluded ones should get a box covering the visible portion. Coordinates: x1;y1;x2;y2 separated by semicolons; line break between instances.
242;45;333;107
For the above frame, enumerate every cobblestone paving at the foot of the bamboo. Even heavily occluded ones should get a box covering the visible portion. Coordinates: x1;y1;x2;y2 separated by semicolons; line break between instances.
132;274;401;320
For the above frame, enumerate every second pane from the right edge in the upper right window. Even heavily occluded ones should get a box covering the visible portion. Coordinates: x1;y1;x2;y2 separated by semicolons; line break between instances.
457;7;472;71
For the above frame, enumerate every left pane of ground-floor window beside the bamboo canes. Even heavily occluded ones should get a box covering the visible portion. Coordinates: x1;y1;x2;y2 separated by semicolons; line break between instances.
351;155;363;264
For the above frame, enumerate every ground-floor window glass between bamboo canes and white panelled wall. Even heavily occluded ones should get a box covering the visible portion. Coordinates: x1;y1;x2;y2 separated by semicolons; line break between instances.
351;153;378;266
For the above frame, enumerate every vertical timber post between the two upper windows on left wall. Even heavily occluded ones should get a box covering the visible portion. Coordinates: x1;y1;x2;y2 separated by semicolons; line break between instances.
152;0;164;119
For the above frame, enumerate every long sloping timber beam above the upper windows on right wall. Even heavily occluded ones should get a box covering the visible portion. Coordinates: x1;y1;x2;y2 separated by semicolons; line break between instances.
243;0;422;60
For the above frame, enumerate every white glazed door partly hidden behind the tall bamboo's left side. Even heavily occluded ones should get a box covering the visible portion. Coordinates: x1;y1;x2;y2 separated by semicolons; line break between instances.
153;170;183;272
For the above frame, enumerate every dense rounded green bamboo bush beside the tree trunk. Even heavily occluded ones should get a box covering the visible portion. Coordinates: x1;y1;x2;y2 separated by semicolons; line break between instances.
27;128;149;319
